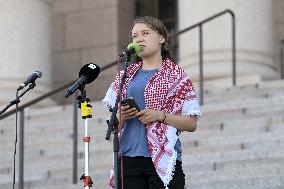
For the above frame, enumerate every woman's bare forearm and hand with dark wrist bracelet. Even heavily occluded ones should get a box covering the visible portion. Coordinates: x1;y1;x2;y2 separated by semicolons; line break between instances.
135;109;197;132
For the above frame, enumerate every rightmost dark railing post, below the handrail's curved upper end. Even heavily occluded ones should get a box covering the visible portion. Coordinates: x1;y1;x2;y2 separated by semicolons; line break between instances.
231;12;237;86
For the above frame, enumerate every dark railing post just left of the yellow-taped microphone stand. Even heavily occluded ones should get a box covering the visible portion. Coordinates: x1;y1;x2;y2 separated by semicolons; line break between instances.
73;98;78;184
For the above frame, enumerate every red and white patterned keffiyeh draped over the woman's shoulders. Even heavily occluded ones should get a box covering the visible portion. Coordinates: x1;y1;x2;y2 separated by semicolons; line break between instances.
103;59;201;188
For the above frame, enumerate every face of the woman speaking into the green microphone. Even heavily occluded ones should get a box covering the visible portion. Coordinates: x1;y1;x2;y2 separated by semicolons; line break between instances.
132;23;165;58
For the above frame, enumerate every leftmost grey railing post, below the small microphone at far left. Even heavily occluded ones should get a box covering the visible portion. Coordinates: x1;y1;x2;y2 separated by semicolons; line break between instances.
19;109;25;189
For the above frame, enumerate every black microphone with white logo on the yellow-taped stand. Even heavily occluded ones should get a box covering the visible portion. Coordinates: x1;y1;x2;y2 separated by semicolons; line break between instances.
65;63;101;98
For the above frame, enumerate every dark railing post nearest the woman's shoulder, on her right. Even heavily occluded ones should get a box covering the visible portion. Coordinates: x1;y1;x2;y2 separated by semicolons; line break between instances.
199;24;203;105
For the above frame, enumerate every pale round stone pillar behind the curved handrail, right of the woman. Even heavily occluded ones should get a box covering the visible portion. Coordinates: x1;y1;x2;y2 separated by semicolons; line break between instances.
179;0;278;87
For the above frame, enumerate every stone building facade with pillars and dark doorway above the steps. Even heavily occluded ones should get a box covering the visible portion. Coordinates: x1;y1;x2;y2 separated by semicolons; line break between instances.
0;0;284;104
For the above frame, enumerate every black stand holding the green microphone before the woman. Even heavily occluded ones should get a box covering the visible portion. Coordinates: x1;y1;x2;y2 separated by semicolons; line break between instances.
105;53;131;189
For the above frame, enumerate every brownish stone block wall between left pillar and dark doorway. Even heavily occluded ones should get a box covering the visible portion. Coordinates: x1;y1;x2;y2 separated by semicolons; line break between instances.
52;0;134;103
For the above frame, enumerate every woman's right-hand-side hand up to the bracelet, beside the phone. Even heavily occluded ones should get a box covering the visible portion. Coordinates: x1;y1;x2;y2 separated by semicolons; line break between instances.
135;109;165;125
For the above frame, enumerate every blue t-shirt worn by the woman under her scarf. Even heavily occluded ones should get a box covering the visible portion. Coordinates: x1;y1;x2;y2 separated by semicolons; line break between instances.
121;69;182;161
